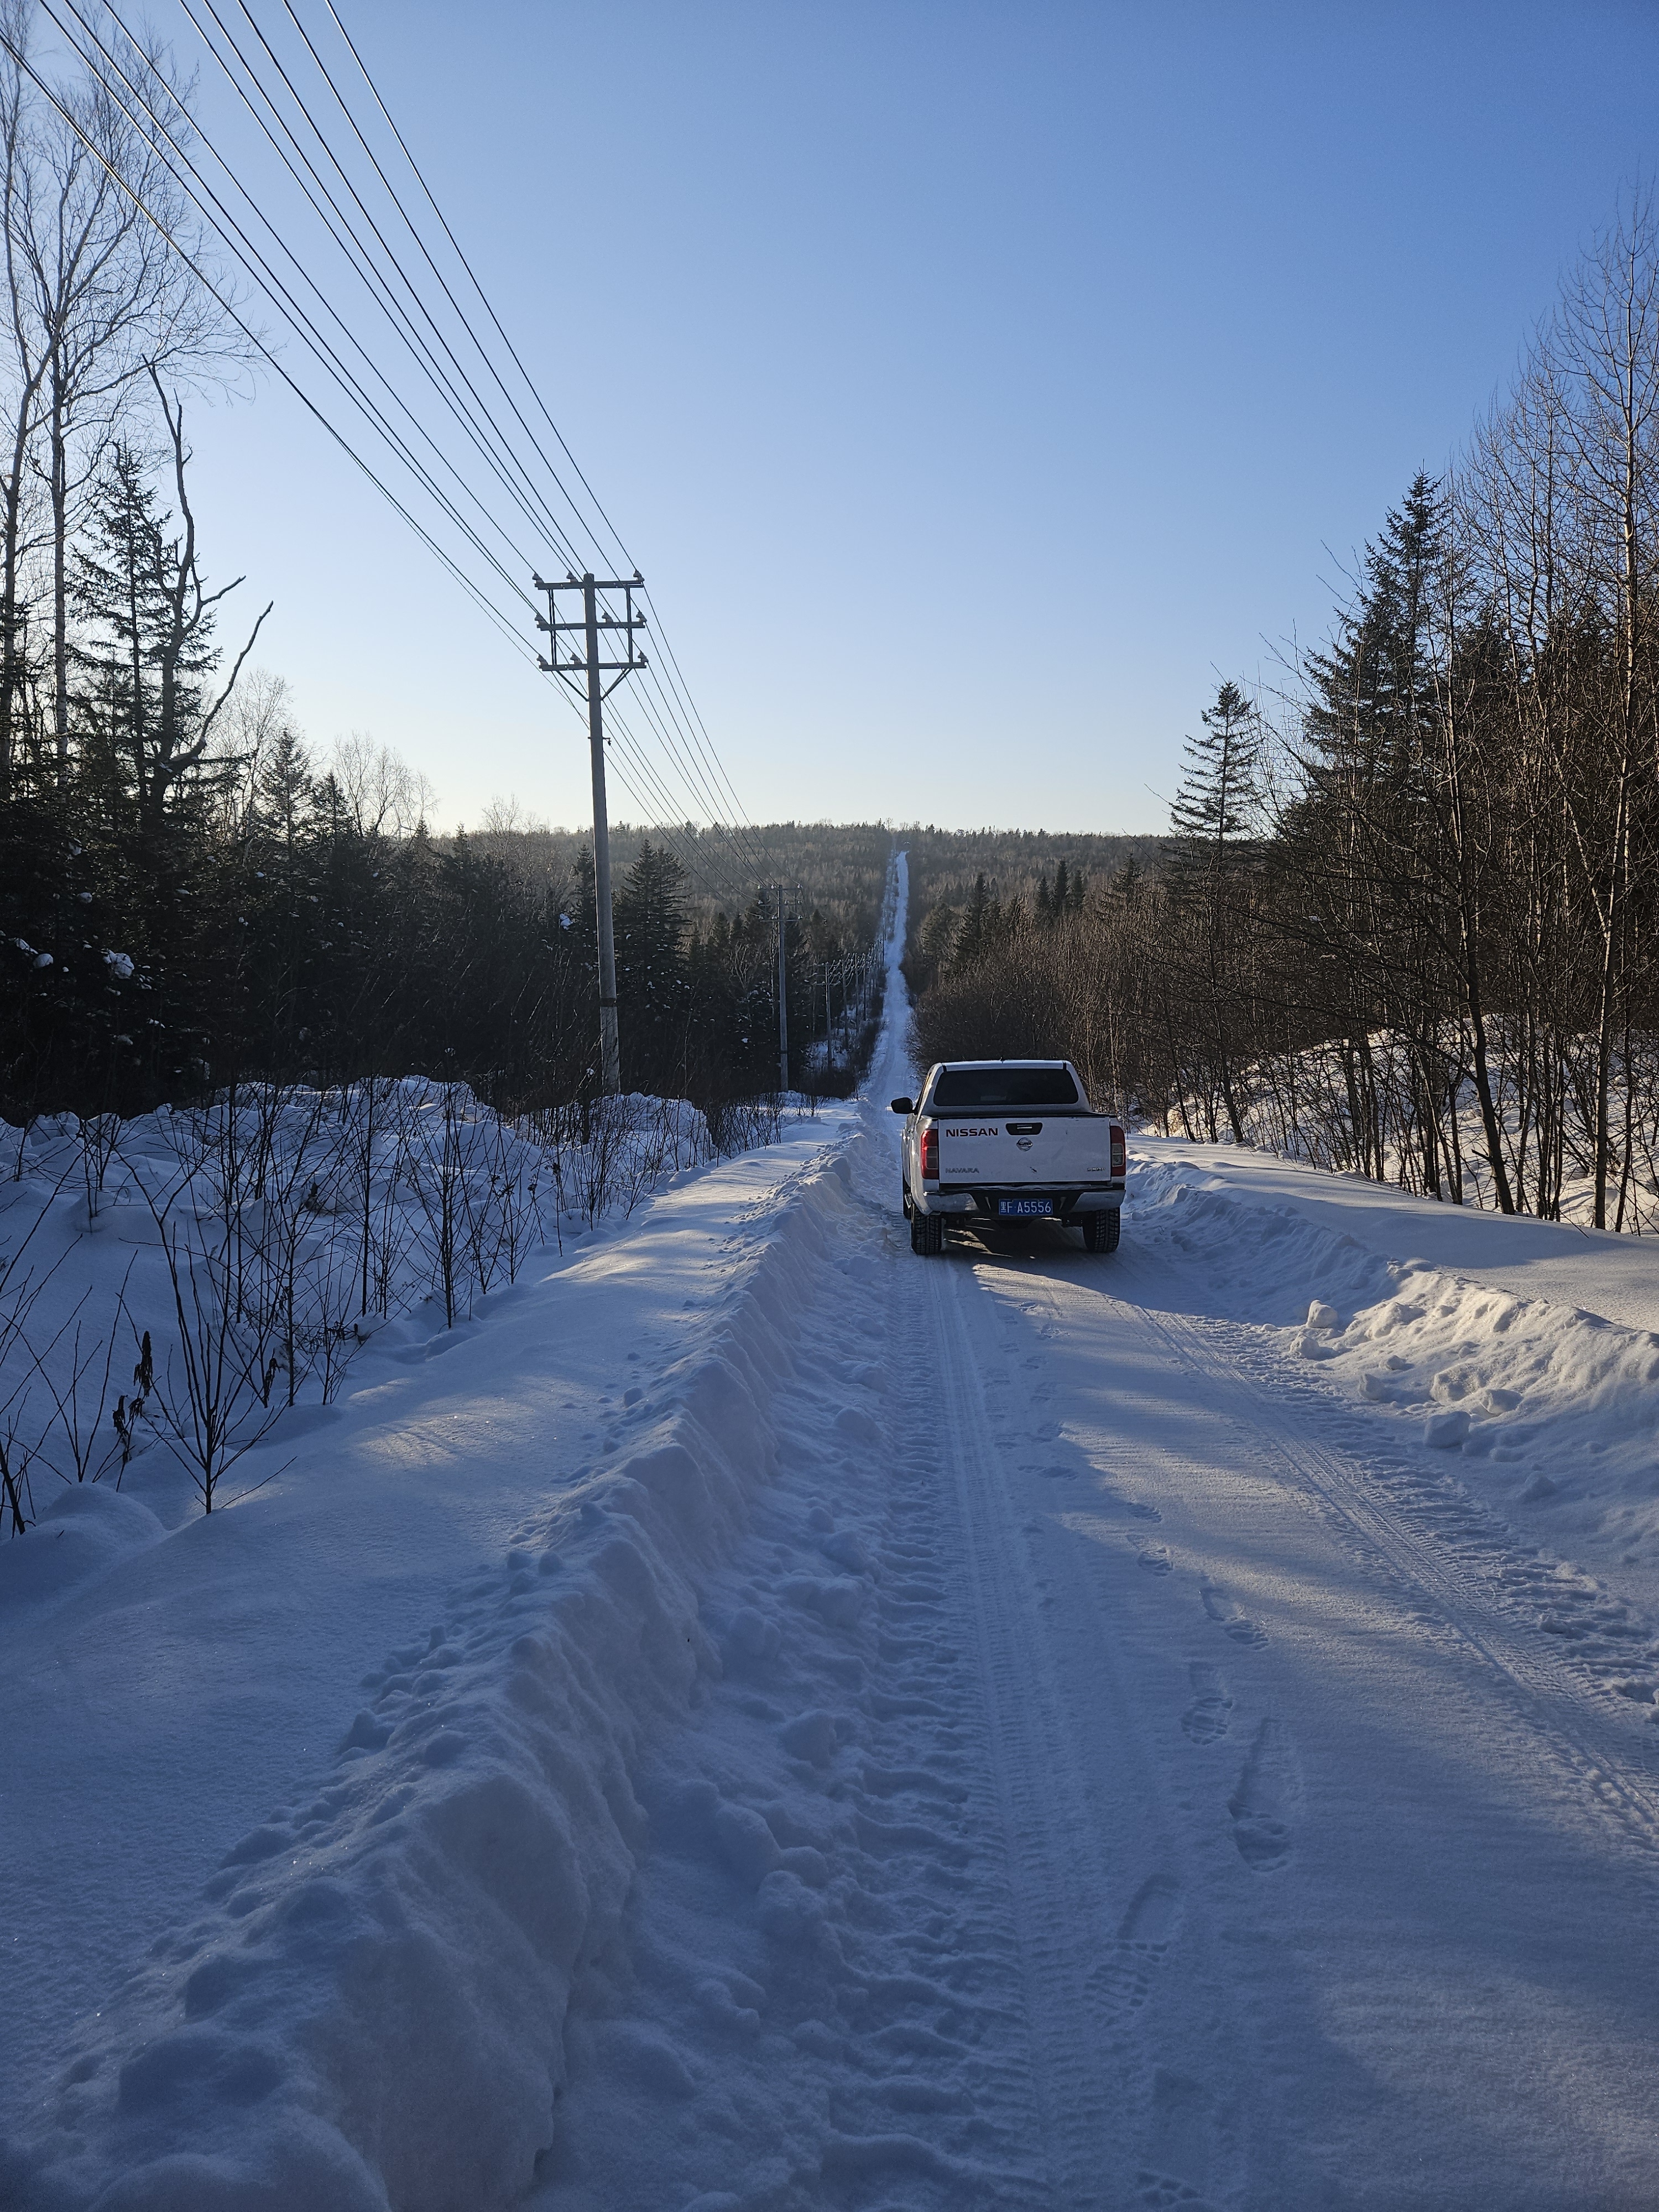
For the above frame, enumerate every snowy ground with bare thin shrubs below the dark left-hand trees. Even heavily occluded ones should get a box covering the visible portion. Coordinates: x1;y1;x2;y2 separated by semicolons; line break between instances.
0;1077;814;1533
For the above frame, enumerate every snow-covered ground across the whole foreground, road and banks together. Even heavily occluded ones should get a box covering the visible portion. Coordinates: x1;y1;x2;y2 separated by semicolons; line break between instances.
0;849;1659;2212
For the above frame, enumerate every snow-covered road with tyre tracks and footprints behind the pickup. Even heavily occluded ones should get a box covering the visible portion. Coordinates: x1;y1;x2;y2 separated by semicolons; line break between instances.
535;876;1659;2212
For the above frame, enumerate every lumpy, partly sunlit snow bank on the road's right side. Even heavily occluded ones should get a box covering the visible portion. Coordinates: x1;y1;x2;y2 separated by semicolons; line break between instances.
1130;1144;1659;1613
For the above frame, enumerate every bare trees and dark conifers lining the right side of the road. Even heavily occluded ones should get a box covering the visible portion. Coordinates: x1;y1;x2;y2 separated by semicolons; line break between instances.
911;197;1659;1228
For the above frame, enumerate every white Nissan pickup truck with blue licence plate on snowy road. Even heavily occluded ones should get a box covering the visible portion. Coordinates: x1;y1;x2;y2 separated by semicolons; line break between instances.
894;1060;1126;1252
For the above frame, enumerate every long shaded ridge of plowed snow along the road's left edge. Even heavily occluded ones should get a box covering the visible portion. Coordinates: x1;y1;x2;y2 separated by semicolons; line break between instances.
0;1139;872;2212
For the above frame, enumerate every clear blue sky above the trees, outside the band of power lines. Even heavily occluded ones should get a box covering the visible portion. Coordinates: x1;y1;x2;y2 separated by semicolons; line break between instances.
166;0;1659;830
